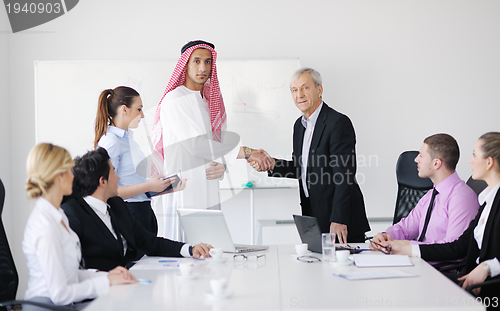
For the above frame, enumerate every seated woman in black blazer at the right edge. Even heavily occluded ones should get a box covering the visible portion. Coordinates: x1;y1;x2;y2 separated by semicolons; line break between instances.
385;132;500;304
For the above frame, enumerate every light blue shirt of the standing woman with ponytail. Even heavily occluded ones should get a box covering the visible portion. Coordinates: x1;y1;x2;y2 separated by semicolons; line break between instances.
97;125;151;202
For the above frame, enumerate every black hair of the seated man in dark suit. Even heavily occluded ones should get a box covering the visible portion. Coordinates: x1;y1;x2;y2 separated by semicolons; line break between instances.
73;148;110;198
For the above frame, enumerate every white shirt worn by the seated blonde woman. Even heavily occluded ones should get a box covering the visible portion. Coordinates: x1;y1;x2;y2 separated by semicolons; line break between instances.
23;197;109;305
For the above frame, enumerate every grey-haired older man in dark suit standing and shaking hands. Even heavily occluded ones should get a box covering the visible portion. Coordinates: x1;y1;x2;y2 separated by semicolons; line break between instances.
252;68;370;243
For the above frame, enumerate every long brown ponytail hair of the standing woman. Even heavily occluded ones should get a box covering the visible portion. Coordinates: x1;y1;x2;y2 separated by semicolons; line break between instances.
94;86;139;148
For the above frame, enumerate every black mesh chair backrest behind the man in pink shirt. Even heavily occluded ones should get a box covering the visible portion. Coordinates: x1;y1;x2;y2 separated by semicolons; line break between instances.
393;151;433;224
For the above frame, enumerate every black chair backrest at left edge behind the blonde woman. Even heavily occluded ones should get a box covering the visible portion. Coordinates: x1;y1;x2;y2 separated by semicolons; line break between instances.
0;179;19;309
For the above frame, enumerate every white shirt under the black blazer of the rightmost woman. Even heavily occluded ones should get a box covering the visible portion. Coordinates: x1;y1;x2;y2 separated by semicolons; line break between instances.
411;183;500;277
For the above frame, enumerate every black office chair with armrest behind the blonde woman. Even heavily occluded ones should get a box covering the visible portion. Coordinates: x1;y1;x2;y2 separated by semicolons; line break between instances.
0;179;75;311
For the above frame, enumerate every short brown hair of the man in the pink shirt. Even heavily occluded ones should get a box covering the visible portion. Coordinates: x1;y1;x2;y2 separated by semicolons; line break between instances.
424;133;460;171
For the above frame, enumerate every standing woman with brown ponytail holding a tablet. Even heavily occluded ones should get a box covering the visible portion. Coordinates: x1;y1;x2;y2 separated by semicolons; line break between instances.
94;86;183;235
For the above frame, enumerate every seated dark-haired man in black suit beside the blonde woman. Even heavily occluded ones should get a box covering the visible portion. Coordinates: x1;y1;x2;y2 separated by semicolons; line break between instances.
61;148;211;271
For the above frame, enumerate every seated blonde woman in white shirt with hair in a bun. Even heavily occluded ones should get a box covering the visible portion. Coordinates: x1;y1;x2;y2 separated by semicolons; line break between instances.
23;143;137;311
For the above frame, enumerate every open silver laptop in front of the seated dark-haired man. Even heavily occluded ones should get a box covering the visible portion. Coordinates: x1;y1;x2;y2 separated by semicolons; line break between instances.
177;209;269;253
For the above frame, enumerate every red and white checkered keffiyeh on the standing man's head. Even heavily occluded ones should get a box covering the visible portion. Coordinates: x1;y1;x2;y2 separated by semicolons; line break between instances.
151;44;226;176
